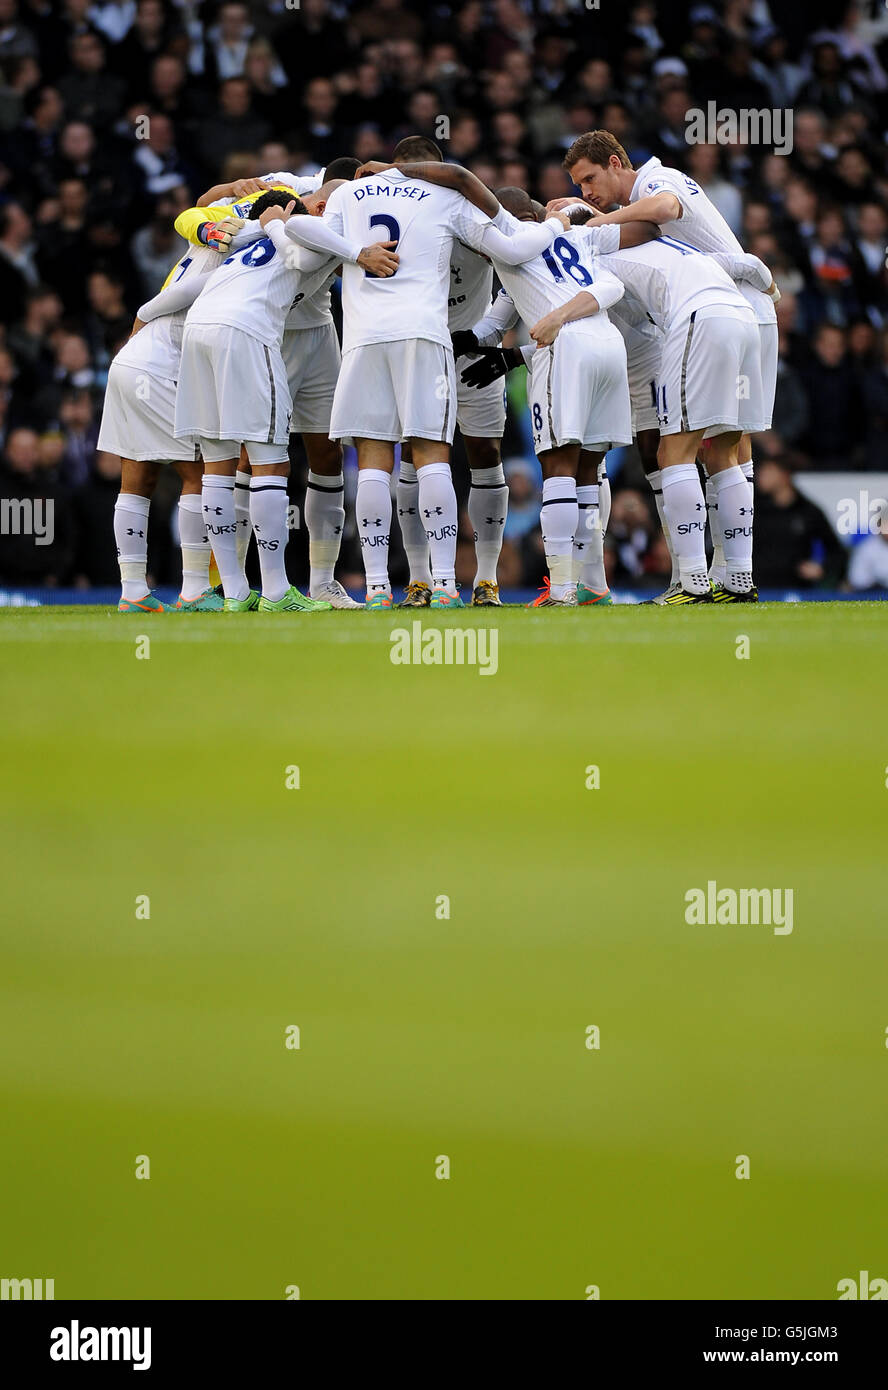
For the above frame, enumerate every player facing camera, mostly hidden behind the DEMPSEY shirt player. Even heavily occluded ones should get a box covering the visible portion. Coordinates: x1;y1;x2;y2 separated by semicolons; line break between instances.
392;135;514;607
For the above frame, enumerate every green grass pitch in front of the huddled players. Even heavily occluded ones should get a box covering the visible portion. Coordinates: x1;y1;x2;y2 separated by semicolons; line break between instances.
0;603;888;1300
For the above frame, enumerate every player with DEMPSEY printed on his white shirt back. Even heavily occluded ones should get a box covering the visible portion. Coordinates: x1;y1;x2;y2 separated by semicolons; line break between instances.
327;164;567;610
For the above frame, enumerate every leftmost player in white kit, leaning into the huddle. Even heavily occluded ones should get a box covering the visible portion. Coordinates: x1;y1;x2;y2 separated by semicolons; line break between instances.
96;218;270;613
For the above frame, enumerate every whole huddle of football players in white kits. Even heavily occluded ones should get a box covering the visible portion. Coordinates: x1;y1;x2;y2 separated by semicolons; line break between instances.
99;131;778;612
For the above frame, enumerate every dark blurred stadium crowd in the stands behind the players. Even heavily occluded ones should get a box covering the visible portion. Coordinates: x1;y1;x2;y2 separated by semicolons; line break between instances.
0;0;888;588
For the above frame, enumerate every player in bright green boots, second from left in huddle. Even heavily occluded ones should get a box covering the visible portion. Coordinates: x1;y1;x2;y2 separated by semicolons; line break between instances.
175;183;397;612
